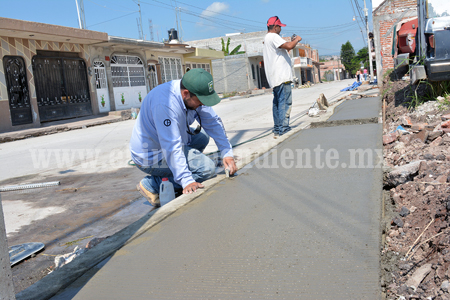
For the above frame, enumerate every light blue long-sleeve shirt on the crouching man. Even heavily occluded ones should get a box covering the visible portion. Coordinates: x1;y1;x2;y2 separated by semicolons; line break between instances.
130;80;233;188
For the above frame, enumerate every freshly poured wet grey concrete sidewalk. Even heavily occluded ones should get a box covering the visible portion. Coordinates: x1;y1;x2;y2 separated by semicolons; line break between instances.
43;98;382;299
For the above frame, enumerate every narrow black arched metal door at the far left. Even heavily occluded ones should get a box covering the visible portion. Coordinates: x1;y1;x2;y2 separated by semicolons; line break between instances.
3;56;33;126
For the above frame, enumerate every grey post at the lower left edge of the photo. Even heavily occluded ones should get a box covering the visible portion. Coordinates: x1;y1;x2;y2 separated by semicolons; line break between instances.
0;193;16;300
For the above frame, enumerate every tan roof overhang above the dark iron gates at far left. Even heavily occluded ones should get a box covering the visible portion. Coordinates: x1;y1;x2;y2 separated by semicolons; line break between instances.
0;17;108;45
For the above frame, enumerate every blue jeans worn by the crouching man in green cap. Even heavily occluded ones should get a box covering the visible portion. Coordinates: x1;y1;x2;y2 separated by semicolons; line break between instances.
136;129;216;194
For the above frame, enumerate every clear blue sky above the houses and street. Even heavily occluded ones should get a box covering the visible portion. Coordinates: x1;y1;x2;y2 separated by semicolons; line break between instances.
0;0;372;55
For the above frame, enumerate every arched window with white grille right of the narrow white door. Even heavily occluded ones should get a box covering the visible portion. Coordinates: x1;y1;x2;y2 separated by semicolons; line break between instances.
111;55;145;87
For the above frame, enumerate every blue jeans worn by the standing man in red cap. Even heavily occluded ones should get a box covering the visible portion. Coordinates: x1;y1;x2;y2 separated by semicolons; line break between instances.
272;83;292;135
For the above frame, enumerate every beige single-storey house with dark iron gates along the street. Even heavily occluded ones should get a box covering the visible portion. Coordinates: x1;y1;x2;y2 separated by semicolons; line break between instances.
0;18;223;133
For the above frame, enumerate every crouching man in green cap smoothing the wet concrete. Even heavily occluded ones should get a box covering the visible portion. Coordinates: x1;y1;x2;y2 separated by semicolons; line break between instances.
130;69;237;207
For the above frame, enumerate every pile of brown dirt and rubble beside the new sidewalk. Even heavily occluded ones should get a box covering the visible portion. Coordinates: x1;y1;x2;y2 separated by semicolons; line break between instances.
381;92;450;300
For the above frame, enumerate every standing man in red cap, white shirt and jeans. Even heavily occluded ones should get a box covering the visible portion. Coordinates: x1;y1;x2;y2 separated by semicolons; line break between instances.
263;16;302;139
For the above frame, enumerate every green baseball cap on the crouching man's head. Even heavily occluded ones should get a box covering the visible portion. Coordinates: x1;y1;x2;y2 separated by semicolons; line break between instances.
181;68;220;106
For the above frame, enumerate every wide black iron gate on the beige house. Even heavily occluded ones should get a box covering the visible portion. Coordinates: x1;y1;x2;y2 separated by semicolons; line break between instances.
33;56;92;122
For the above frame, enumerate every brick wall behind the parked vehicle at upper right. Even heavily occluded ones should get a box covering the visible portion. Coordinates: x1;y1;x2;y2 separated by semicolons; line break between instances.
373;0;417;82
